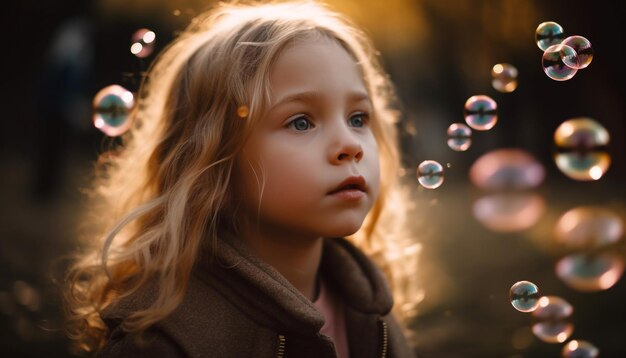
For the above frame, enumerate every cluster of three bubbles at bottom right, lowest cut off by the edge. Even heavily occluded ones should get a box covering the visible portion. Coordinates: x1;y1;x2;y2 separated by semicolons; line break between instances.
509;281;599;358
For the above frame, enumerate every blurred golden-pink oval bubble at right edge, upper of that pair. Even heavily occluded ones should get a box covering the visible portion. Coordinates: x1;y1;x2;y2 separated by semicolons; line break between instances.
555;206;624;249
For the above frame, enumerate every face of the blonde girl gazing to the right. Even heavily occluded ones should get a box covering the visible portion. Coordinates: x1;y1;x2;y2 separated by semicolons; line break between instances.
237;38;379;238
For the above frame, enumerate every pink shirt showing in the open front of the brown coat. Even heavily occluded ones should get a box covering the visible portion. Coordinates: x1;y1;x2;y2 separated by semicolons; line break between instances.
313;281;350;358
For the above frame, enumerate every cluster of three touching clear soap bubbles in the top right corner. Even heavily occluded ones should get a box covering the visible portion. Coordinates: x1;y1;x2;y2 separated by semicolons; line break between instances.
535;21;593;81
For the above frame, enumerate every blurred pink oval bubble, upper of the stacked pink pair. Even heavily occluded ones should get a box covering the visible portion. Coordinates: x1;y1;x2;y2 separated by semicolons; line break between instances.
469;148;544;190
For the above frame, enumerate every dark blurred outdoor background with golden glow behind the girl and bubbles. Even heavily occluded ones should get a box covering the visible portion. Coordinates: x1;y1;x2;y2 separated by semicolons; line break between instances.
0;0;626;358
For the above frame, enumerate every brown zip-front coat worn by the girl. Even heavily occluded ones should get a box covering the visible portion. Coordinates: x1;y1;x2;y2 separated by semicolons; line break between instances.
98;239;413;358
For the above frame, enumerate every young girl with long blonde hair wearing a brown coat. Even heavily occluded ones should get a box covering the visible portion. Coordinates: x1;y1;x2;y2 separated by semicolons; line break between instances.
67;2;417;357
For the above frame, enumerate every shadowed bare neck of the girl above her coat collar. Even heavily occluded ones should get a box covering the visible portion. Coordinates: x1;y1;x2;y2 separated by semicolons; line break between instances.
242;228;323;301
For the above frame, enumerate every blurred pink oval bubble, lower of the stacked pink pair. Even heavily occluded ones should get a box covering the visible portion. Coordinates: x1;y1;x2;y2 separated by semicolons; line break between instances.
472;193;546;232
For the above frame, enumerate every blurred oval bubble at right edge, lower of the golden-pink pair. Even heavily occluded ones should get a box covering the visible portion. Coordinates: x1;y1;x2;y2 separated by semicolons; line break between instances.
555;253;624;292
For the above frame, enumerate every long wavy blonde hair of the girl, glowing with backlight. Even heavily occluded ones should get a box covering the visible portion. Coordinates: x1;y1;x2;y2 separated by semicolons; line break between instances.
65;2;419;350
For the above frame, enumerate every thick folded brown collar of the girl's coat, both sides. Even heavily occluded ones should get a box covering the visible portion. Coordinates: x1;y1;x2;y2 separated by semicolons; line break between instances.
196;238;393;335
